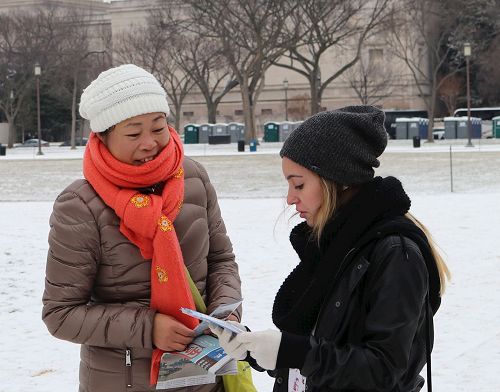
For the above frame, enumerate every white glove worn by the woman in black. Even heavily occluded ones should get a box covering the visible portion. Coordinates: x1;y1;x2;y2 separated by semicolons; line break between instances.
235;329;281;370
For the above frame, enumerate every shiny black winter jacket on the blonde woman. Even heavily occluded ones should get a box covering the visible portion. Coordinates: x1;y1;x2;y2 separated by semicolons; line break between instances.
274;236;428;392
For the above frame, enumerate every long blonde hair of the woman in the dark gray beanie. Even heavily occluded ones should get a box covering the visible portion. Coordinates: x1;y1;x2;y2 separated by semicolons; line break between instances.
312;176;451;295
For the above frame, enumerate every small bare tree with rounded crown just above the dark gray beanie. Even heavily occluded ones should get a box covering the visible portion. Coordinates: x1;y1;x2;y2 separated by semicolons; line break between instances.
346;49;393;105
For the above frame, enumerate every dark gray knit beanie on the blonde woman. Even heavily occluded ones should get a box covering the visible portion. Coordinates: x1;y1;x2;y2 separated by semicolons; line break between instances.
280;106;387;185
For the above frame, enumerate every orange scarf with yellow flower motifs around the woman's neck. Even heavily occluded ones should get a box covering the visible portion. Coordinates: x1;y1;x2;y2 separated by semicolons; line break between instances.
83;126;198;385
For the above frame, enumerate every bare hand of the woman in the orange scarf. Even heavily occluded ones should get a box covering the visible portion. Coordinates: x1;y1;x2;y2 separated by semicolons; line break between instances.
153;313;194;351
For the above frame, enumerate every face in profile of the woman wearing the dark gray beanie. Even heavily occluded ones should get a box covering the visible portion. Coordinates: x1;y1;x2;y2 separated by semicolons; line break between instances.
281;157;323;226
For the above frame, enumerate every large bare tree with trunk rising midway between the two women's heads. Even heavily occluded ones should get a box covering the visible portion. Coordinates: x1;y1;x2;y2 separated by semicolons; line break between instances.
185;0;298;141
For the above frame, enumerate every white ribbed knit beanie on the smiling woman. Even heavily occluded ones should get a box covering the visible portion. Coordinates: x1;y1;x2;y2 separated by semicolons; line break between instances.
80;64;170;132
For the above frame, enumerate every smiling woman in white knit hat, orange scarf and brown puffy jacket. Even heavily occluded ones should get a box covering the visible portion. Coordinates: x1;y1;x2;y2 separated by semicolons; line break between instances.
43;64;241;392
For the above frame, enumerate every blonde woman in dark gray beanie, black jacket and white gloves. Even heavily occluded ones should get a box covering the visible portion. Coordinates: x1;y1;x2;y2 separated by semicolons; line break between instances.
211;106;449;392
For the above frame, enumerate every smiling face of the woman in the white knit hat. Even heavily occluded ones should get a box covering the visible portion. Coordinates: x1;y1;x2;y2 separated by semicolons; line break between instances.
97;113;170;166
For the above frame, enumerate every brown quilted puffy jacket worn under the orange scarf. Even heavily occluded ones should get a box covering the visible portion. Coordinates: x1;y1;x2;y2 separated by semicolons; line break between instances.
42;158;241;392
